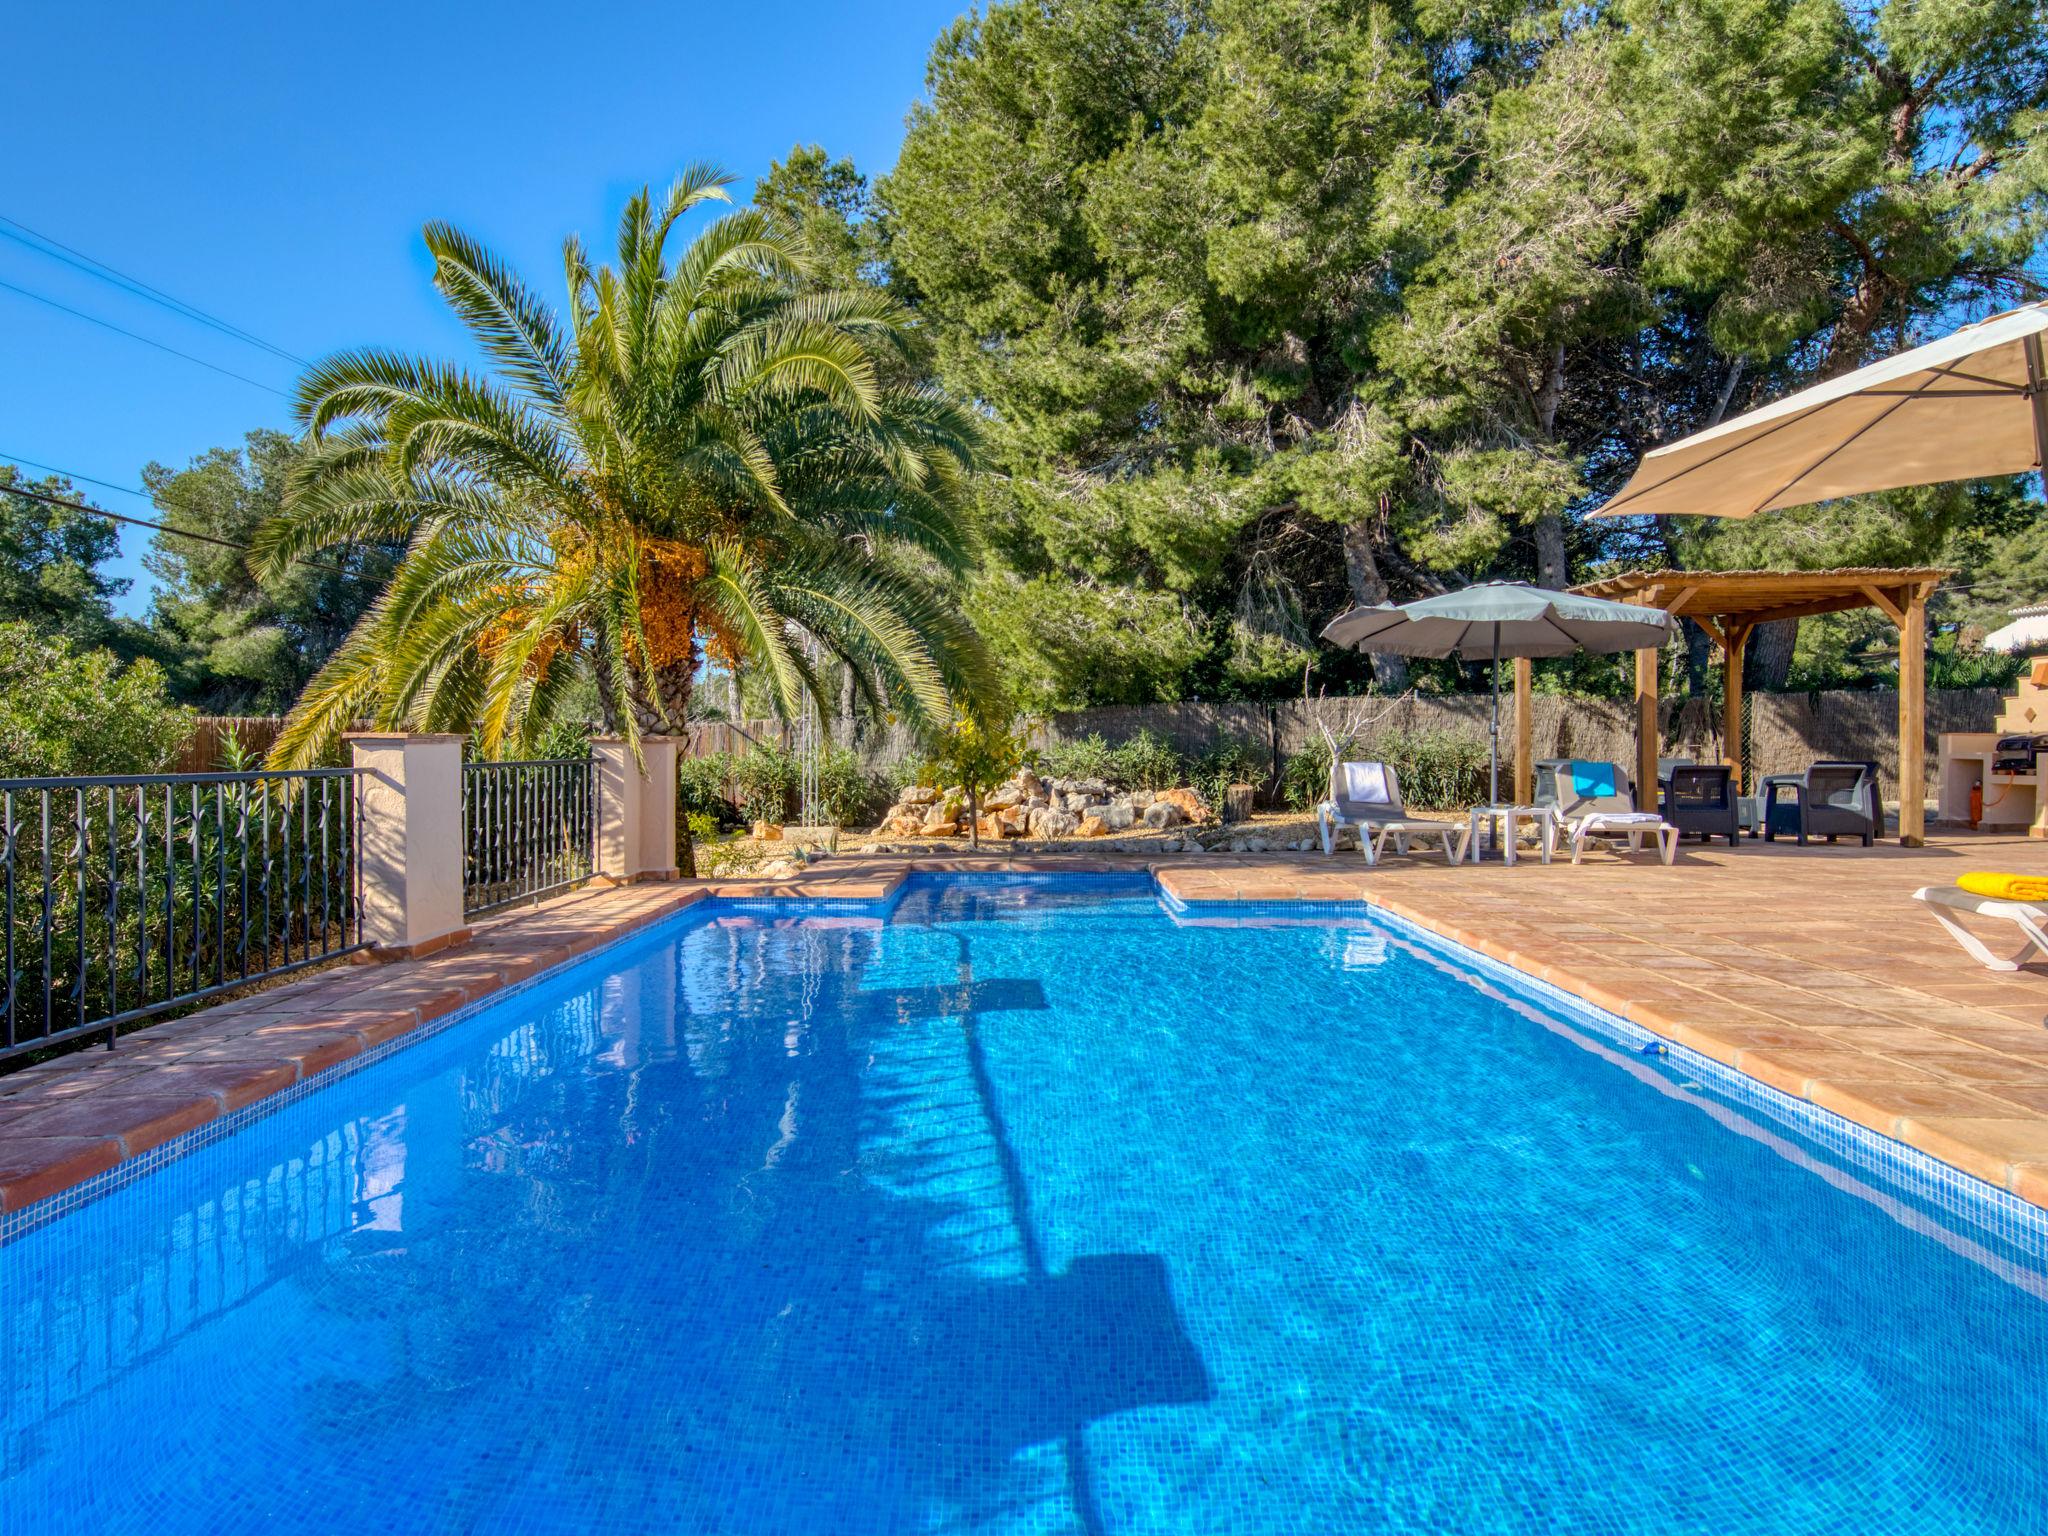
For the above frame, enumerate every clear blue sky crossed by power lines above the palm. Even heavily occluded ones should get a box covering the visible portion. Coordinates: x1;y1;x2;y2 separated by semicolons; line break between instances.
0;0;965;610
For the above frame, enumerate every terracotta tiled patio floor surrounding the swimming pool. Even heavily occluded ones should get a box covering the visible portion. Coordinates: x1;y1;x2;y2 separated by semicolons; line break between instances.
0;834;2048;1210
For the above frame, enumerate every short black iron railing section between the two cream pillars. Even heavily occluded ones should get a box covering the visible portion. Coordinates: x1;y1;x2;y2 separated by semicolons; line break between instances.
463;758;598;915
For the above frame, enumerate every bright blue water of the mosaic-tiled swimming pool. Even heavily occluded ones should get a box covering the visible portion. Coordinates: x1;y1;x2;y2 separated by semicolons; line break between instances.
0;881;2048;1536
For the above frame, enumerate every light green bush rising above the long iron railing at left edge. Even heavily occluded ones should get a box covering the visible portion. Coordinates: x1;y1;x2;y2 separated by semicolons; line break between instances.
0;621;193;778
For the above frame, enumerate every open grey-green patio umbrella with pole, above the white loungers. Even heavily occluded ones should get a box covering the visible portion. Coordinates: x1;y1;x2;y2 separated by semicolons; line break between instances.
1323;582;1671;805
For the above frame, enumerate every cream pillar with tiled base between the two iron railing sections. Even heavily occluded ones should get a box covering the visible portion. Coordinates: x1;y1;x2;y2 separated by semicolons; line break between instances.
344;731;469;958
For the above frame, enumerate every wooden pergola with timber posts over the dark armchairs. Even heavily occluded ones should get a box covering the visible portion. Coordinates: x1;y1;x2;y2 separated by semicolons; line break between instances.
1516;567;1954;848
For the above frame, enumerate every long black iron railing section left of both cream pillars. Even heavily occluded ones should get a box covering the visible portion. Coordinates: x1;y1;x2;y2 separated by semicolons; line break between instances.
0;768;362;1061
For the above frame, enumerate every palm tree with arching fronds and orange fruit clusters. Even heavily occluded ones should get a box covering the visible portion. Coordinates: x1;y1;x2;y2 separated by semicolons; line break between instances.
256;166;993;766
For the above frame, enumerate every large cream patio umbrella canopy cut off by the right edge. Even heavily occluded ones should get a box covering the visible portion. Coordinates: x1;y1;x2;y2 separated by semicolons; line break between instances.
1593;303;2048;518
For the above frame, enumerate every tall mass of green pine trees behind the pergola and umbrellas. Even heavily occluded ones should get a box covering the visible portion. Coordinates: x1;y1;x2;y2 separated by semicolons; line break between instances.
880;0;2048;709
